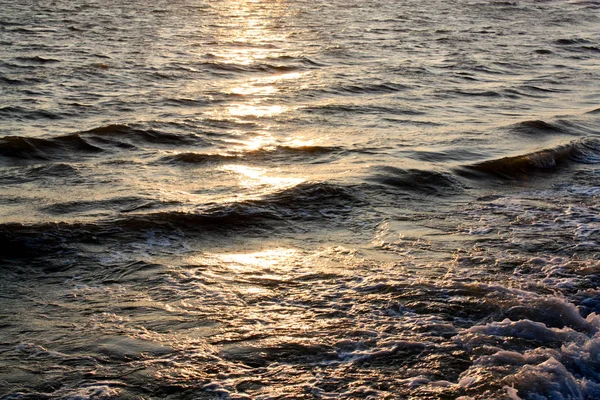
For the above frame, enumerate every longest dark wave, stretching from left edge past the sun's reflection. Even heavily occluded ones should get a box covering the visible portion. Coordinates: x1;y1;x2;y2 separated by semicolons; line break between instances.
0;182;361;259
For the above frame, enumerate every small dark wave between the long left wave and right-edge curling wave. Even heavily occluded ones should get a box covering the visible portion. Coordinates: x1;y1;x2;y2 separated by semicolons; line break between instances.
369;166;462;195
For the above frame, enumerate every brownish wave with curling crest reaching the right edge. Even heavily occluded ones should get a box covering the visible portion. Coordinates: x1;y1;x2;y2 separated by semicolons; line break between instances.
457;138;600;179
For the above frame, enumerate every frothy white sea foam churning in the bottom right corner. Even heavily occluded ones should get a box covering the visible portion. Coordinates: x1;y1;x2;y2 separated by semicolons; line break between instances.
456;307;600;400
